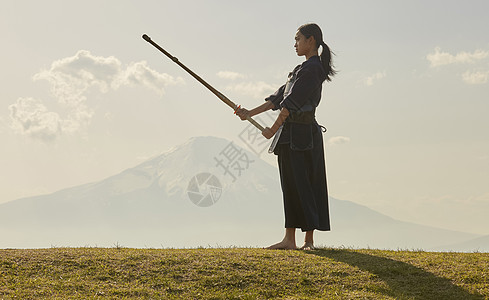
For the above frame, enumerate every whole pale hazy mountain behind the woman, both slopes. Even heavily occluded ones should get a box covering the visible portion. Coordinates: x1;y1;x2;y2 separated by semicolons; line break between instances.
0;137;478;249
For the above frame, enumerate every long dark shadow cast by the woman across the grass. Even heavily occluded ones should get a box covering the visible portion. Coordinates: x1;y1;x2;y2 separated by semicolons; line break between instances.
307;249;484;300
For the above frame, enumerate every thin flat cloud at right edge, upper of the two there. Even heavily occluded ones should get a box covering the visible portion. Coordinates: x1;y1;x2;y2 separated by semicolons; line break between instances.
426;47;489;67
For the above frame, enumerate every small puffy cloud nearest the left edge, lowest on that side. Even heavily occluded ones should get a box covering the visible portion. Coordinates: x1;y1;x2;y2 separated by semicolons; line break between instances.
9;98;62;141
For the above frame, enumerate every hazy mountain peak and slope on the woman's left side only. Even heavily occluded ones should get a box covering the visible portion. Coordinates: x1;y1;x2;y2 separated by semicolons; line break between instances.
0;137;281;247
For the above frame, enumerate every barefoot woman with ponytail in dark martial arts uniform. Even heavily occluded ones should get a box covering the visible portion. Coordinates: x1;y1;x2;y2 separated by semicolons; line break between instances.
236;24;336;249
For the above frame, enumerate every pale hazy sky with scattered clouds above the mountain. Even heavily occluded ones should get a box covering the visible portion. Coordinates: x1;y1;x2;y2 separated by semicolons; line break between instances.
0;0;489;234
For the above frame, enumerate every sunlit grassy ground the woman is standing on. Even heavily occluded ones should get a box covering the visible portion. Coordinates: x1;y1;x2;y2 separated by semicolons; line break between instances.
0;247;489;299
